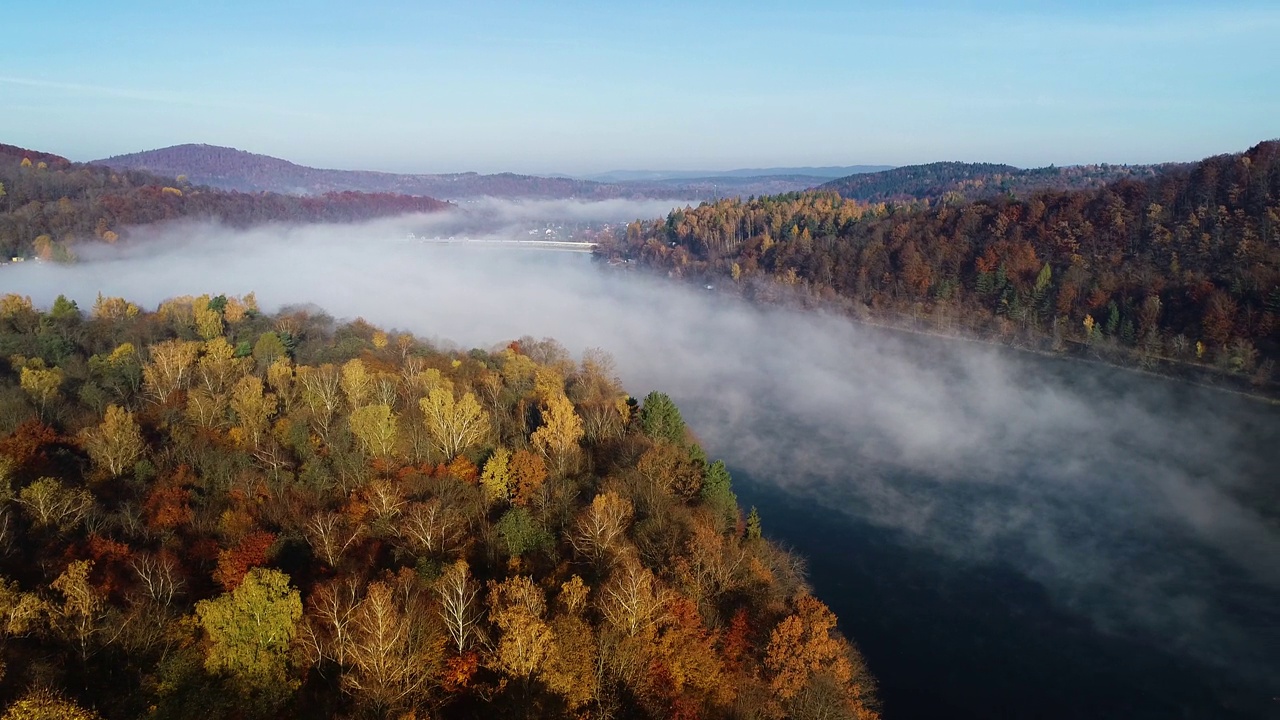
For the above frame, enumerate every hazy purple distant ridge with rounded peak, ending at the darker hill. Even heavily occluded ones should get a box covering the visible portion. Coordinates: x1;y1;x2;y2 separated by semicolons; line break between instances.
93;145;844;201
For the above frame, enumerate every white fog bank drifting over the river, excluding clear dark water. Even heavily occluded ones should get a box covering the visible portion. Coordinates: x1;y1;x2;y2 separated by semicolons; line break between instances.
0;202;1280;712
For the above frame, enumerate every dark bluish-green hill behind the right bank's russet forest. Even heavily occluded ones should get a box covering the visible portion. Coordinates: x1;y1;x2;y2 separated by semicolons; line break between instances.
817;163;1178;202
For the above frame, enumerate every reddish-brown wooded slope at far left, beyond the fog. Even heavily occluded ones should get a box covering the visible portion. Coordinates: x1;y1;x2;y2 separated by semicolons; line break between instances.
0;145;449;260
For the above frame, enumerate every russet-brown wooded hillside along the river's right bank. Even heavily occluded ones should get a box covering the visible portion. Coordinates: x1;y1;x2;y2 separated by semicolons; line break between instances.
598;141;1280;386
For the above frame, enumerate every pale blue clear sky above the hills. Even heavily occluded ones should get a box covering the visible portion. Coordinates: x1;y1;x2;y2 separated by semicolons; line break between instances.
0;0;1280;173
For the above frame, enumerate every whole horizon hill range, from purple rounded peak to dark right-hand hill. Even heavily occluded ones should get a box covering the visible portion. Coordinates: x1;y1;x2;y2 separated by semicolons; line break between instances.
92;145;1181;204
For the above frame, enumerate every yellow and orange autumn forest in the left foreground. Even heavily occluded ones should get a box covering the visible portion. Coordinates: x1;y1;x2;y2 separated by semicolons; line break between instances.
0;295;877;719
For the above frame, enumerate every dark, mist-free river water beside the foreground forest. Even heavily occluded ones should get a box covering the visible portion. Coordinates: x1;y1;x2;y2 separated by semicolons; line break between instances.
739;474;1280;719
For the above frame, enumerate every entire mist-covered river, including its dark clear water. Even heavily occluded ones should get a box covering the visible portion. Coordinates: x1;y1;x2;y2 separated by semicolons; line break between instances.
0;213;1280;717
